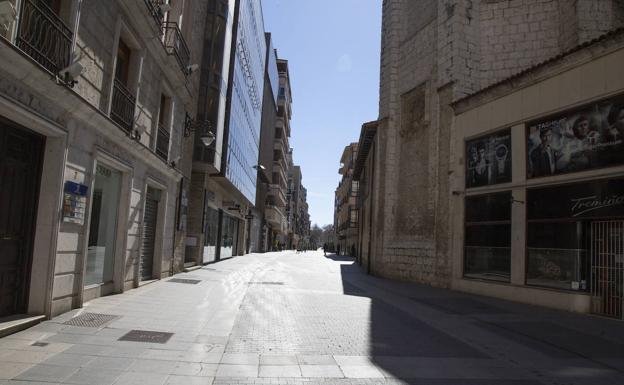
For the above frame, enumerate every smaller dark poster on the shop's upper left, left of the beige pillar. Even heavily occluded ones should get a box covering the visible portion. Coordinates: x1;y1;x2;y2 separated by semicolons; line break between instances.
466;129;511;188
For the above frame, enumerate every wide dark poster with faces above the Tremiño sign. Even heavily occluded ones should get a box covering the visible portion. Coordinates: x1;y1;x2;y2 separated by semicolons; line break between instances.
527;96;624;178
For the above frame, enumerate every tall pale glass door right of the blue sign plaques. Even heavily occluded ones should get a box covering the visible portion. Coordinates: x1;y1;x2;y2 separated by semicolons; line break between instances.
84;164;121;286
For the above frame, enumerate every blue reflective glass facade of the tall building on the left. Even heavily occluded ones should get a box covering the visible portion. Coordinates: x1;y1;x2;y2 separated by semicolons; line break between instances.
225;0;266;203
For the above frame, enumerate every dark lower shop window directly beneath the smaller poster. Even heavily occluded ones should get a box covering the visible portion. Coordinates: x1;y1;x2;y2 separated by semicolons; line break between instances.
464;191;511;282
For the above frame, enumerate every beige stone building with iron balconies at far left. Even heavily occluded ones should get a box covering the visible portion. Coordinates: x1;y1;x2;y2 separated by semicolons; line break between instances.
0;0;206;317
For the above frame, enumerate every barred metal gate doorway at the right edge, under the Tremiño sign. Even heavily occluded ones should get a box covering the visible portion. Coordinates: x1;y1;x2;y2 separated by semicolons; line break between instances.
590;220;624;319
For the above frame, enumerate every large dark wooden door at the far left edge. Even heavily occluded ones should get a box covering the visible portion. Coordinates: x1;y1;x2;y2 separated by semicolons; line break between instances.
0;120;45;317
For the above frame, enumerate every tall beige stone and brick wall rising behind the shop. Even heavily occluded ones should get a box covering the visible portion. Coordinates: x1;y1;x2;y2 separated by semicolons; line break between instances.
371;0;622;286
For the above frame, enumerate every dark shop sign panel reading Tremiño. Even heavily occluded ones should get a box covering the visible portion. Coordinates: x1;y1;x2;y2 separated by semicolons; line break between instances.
527;179;624;219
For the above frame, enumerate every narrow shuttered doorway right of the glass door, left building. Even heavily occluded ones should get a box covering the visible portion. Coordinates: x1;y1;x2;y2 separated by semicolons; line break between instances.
140;186;160;281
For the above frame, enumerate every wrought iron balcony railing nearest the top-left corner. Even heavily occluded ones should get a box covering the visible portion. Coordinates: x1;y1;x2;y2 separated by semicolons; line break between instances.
16;0;73;74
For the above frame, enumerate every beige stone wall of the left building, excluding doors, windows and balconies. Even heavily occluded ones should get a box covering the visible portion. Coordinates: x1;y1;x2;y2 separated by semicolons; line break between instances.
0;0;205;315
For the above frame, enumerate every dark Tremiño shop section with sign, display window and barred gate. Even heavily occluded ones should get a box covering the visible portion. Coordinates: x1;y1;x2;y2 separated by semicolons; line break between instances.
526;179;624;318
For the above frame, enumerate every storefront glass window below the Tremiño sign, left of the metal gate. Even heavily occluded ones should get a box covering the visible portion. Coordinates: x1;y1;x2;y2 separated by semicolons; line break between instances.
527;221;588;290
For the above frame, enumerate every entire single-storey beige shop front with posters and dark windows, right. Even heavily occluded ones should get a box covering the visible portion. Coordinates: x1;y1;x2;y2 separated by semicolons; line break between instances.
450;35;624;319
